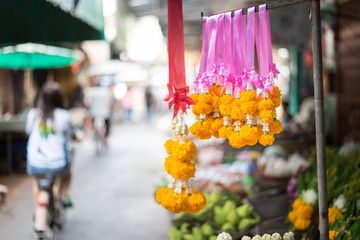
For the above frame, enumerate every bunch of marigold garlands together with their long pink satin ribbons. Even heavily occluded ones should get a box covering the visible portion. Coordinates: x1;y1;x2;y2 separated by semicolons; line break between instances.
190;5;283;148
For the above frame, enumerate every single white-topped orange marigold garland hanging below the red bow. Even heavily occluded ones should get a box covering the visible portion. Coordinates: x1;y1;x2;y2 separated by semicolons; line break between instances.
155;111;206;214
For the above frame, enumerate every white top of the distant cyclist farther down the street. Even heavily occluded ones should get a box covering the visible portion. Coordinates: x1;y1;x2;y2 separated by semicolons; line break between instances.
88;86;113;119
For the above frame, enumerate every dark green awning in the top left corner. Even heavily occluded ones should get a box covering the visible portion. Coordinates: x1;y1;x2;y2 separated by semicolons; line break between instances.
0;0;104;44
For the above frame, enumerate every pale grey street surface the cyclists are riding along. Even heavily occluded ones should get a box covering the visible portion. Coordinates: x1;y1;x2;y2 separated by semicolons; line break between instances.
0;124;170;240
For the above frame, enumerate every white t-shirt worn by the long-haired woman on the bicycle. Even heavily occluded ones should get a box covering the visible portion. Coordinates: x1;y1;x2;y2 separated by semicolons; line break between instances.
26;108;73;169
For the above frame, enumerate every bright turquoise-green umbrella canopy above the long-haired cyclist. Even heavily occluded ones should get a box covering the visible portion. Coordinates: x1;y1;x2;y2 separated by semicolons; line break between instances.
0;43;81;69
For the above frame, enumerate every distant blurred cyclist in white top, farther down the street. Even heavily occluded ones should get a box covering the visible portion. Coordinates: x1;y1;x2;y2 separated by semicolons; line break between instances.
87;80;114;145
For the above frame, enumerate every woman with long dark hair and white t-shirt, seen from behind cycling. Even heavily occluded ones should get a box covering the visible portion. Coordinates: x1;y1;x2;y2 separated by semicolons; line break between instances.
26;82;73;234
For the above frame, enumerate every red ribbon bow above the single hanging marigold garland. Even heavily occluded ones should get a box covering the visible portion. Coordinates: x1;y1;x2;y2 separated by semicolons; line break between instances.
164;84;195;118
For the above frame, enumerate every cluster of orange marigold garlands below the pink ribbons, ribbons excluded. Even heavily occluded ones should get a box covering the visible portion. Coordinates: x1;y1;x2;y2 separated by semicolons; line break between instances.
190;73;283;148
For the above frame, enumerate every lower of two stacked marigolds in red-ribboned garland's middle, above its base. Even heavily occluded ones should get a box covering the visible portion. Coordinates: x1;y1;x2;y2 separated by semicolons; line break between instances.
164;156;196;179
